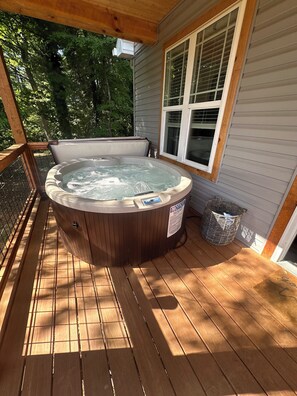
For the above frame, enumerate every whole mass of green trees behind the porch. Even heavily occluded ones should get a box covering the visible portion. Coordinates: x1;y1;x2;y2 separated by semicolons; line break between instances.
0;12;133;149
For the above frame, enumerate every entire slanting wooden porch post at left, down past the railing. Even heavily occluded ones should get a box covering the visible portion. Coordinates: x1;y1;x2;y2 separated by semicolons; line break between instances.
0;47;41;191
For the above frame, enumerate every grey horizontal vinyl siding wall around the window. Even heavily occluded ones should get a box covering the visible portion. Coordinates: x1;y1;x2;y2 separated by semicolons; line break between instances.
134;0;297;252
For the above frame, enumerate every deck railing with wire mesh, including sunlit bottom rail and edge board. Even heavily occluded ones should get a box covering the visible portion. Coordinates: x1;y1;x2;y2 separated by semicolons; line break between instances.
0;143;52;344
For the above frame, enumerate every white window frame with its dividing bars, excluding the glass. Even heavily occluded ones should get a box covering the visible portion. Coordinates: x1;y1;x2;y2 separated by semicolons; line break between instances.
160;0;247;173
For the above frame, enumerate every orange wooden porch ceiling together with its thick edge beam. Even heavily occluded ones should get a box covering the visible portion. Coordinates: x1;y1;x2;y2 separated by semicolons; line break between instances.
0;0;181;44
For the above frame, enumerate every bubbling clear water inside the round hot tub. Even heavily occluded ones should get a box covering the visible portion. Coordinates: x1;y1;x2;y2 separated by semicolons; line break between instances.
63;164;180;200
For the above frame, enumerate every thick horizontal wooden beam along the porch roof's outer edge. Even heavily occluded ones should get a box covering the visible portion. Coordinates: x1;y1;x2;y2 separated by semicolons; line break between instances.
0;0;157;44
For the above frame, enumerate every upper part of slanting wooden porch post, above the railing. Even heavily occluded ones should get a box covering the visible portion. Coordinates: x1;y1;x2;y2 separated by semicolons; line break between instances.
0;48;27;143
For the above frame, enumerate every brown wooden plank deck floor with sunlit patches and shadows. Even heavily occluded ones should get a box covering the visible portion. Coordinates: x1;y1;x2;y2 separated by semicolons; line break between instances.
0;203;297;396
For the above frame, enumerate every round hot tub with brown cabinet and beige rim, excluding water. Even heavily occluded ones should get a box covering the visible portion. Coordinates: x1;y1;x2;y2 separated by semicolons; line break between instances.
46;157;192;266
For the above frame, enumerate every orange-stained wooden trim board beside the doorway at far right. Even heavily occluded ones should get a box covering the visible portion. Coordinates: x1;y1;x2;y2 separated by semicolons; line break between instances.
262;176;297;258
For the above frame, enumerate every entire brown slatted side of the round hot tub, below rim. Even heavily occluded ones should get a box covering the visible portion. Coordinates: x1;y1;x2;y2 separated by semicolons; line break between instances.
49;197;188;267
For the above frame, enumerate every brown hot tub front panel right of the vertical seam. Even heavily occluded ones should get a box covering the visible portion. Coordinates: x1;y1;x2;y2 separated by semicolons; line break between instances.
85;205;183;266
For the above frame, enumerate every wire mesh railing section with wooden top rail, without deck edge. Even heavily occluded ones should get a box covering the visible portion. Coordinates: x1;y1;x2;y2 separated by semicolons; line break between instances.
0;143;53;272
